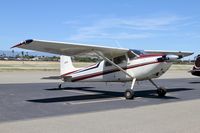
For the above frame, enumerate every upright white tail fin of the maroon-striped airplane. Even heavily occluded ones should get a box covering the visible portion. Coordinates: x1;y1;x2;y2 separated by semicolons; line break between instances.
60;55;76;75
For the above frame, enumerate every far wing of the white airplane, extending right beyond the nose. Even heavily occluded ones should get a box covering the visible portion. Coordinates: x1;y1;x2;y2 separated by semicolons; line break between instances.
144;50;193;58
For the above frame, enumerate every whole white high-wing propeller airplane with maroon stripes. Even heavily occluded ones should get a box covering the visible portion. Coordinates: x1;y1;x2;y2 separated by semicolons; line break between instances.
12;39;193;99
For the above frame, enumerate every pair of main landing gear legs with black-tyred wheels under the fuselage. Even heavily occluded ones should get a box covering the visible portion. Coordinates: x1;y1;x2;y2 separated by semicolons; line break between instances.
124;78;167;100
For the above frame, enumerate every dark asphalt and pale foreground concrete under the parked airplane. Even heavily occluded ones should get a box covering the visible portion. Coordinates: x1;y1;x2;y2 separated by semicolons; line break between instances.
0;71;200;133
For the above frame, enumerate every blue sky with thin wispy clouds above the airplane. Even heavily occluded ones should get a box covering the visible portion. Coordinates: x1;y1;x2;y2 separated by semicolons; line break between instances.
0;0;200;57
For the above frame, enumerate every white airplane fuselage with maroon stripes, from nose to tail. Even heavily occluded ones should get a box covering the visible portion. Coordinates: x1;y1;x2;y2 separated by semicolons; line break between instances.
62;54;172;82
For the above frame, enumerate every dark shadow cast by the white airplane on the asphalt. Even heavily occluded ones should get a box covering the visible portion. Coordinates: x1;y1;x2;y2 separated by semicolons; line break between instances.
27;87;193;103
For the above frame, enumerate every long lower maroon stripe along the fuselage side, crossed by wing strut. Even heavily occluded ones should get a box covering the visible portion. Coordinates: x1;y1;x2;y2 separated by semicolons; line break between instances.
72;61;160;82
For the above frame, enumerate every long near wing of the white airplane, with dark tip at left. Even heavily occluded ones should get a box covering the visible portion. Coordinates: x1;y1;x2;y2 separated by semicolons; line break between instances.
12;39;129;58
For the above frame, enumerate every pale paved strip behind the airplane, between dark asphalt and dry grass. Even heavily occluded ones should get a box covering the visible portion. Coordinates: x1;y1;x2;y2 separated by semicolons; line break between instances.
0;69;195;84
